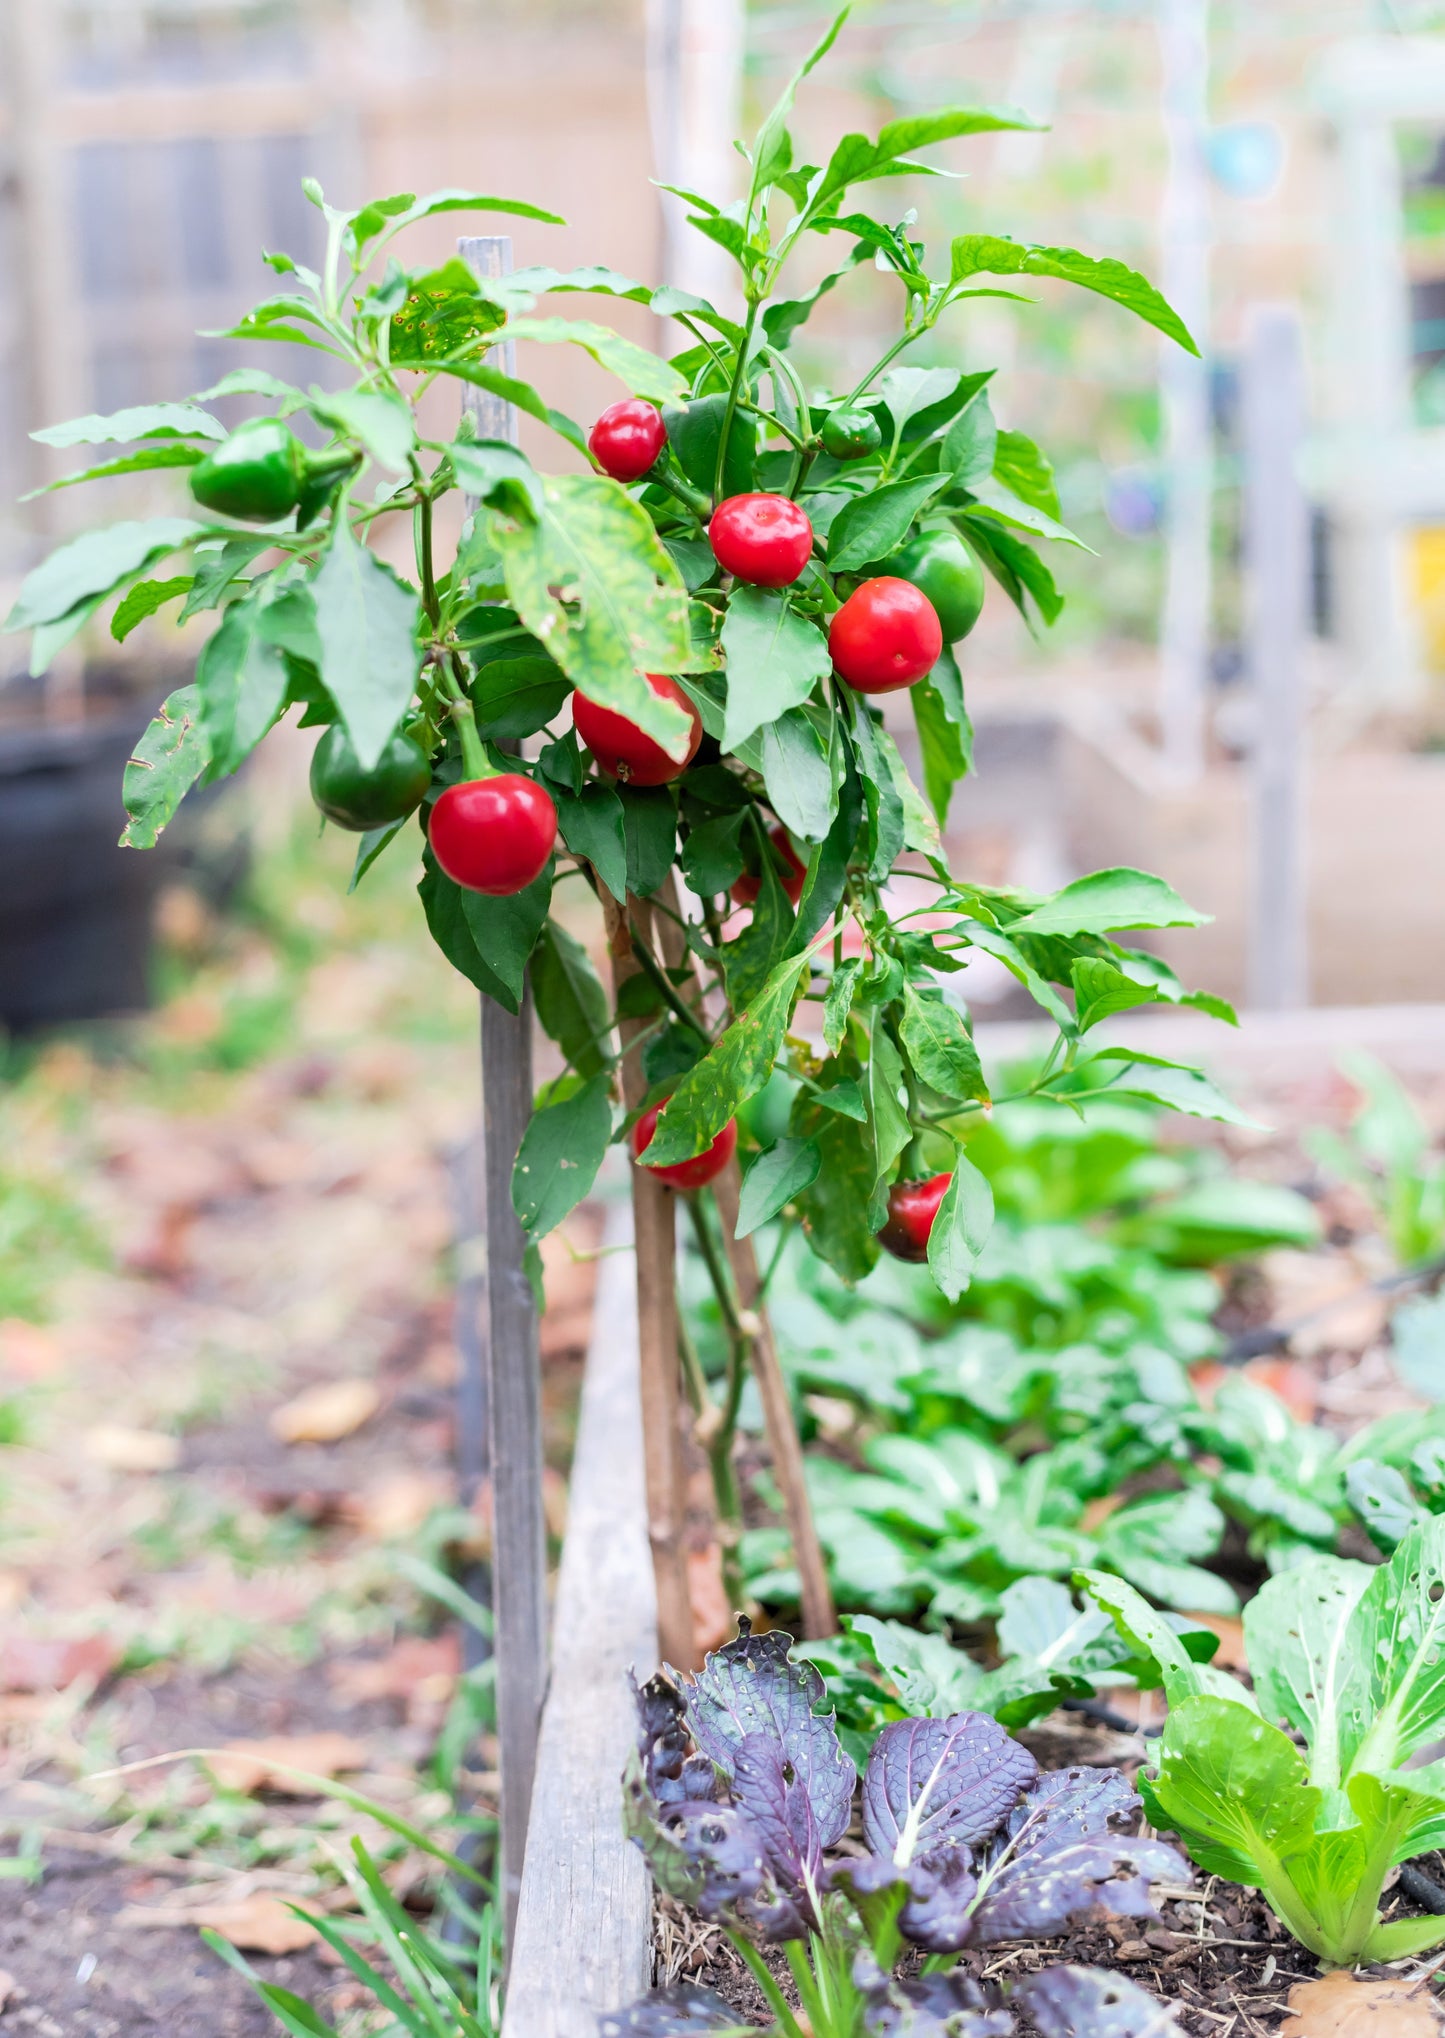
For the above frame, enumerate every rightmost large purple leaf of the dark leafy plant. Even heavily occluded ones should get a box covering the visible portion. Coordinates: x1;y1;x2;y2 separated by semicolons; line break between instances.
972;1769;1188;1944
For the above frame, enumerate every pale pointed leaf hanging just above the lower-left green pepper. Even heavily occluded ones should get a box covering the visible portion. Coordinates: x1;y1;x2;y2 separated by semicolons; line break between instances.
312;516;422;770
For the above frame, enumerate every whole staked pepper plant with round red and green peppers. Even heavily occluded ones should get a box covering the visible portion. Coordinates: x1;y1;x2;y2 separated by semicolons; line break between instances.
8;10;1231;1597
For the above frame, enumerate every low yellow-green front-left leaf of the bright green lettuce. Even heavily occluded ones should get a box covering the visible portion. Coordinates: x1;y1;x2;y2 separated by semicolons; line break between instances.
1149;1696;1323;1889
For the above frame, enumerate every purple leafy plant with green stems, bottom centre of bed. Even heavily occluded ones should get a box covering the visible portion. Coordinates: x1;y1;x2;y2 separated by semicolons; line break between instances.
603;1620;1186;2038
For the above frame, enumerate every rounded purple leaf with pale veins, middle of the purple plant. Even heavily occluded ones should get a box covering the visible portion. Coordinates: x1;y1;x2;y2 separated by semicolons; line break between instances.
862;1712;1039;1867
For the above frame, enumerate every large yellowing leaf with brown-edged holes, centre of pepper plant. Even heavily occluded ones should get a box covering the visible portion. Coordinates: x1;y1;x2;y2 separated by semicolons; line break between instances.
489;475;691;758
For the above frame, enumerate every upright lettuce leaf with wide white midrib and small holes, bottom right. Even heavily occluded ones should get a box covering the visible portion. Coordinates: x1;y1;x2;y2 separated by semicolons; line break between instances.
1243;1557;1374;1789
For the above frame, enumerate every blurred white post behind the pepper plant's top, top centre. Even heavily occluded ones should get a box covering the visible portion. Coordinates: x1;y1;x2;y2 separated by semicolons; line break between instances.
646;0;748;310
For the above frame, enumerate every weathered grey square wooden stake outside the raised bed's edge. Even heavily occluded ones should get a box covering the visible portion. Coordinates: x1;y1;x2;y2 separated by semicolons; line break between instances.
457;234;546;1956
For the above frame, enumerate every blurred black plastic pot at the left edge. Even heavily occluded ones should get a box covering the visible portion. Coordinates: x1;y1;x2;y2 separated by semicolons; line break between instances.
0;707;239;1033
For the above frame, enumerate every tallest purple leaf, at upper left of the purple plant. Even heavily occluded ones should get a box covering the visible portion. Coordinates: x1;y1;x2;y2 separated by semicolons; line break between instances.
683;1620;854;1846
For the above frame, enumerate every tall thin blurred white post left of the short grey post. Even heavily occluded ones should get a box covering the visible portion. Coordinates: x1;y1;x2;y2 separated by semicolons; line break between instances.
1160;0;1213;781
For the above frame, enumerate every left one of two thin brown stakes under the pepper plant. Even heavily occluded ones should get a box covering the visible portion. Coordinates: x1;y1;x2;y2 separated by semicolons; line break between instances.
599;887;695;1667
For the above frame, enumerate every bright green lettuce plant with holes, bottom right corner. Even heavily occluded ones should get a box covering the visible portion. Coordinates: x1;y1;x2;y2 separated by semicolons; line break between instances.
1080;1516;1445;1967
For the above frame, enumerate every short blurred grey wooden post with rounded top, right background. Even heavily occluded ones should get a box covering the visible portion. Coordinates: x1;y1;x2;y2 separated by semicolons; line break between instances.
1241;304;1310;1011
